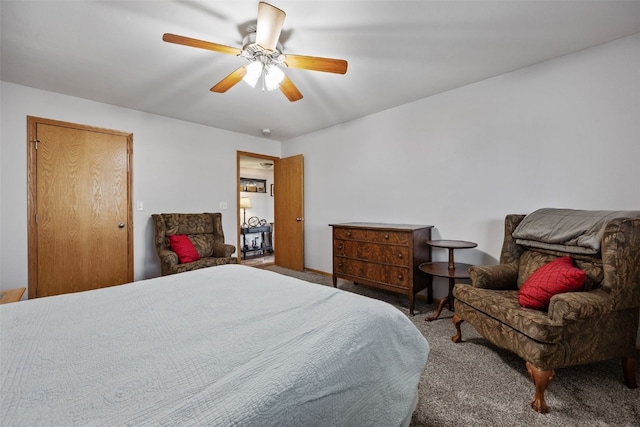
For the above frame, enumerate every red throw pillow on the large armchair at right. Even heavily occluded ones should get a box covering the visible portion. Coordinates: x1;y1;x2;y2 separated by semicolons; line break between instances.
518;256;587;310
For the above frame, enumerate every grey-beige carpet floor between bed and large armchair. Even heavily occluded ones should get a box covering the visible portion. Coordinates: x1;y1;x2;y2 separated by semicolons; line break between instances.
265;266;640;427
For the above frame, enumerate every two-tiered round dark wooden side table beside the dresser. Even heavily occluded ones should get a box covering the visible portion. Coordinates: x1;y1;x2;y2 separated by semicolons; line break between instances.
418;240;478;322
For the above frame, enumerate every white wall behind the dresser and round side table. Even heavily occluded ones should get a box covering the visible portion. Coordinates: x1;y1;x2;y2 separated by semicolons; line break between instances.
282;35;640;342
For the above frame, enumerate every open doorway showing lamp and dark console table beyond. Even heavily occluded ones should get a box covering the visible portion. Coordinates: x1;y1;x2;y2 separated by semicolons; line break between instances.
237;152;276;266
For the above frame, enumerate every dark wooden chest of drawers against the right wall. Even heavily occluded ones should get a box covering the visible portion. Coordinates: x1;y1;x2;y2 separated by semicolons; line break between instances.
330;222;433;315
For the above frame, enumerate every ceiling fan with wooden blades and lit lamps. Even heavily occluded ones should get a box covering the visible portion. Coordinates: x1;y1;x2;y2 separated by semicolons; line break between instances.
162;2;347;102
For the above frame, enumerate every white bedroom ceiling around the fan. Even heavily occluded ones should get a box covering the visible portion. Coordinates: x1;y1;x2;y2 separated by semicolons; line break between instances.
0;0;640;141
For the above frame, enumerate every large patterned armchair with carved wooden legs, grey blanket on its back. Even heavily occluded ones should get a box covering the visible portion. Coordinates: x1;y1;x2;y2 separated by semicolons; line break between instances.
451;215;640;413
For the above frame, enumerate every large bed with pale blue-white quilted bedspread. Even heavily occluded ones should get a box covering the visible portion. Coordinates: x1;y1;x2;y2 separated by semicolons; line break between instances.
0;265;429;426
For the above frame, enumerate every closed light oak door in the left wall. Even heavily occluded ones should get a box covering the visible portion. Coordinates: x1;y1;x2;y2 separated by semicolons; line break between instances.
28;117;133;298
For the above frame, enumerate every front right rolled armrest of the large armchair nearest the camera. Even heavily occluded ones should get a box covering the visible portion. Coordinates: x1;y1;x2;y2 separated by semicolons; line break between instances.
549;289;613;322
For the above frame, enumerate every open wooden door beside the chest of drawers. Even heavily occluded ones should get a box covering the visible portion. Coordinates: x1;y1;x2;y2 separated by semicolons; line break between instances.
273;155;304;271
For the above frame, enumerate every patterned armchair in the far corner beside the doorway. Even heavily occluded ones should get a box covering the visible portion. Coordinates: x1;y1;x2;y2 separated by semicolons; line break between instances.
151;213;238;276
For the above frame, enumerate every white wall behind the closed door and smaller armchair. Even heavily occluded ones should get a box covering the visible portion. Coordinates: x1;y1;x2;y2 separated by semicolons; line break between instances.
0;82;281;289
